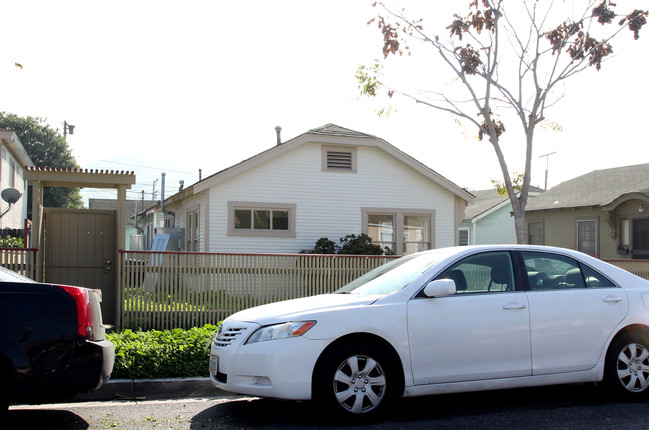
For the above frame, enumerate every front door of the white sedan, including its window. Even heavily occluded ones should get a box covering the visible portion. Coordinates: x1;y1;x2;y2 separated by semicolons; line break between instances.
407;251;531;385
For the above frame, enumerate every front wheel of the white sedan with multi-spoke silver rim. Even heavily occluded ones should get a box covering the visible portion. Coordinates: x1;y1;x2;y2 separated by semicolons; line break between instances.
314;343;403;421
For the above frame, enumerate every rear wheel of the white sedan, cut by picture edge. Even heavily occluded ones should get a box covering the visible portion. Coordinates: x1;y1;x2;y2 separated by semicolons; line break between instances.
604;334;649;401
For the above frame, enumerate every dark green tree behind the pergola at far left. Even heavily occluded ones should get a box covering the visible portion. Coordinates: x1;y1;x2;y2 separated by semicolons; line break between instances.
0;112;83;208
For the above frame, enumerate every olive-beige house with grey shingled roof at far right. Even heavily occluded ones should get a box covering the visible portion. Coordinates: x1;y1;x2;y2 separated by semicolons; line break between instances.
526;164;649;259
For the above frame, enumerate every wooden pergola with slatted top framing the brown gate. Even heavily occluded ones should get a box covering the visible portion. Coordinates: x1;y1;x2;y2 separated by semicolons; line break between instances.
25;166;135;282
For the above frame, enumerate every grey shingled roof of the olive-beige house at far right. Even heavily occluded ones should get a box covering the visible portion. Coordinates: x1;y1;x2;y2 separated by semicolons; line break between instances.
526;164;649;211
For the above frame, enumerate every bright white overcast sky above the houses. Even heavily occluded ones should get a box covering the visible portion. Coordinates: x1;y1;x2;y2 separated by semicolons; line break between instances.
0;0;649;205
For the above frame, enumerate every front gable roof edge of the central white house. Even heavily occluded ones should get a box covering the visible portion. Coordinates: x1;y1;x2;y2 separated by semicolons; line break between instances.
192;123;474;202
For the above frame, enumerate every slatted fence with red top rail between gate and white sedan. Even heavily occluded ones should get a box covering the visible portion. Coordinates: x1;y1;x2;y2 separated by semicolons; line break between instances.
118;251;395;330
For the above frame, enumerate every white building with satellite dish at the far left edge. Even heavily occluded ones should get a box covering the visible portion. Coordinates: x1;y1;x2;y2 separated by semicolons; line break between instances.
0;129;34;230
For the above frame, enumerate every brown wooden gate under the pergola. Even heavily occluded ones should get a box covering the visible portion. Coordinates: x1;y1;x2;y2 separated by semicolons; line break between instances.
44;208;117;324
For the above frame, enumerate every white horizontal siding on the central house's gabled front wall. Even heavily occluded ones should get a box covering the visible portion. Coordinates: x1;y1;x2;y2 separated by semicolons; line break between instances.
207;143;455;253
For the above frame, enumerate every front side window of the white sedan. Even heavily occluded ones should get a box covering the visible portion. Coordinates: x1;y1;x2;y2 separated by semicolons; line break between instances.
435;251;514;294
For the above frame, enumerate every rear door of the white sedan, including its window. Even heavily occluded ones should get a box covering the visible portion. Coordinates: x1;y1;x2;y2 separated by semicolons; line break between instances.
521;252;628;375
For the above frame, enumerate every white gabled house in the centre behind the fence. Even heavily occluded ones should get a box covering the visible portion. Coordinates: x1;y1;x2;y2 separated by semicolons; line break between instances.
139;124;474;254
